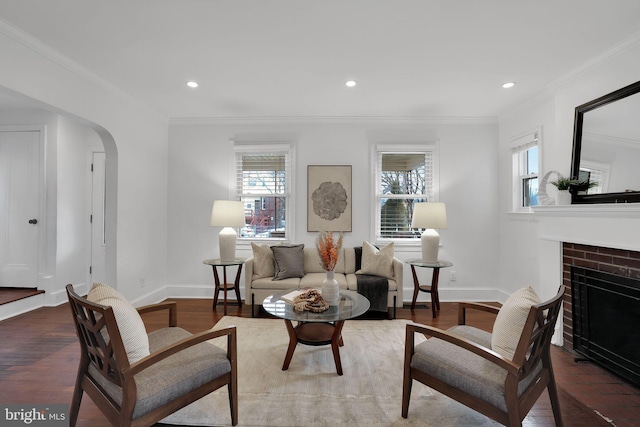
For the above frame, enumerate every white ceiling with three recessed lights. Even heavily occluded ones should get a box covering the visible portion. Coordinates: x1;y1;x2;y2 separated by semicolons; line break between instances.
0;0;640;119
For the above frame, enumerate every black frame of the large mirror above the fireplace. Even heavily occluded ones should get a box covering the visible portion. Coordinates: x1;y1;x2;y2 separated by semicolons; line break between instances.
571;81;640;204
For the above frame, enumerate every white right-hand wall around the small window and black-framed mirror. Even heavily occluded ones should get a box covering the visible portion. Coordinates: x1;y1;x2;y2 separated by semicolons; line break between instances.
499;42;640;300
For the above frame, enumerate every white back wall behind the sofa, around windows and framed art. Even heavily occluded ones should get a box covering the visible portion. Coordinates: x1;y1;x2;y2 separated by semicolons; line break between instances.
168;121;498;300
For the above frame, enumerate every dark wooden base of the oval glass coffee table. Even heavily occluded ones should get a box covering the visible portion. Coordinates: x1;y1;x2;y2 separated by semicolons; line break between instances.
282;319;344;375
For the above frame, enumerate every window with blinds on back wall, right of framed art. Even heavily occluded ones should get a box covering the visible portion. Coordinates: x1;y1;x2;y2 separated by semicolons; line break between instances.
375;145;437;241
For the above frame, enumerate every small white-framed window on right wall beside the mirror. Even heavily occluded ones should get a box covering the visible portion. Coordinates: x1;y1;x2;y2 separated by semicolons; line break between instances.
511;129;542;212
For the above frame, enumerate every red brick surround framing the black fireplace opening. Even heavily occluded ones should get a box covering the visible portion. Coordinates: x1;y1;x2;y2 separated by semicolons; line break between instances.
562;242;640;350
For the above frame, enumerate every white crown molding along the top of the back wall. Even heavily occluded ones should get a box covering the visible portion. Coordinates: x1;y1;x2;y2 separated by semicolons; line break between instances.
169;116;498;126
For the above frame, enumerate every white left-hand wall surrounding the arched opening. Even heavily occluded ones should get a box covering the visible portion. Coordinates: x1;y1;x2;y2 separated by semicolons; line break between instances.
0;25;167;303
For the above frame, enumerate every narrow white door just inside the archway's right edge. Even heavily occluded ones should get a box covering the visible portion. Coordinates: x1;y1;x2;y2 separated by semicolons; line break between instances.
90;152;107;283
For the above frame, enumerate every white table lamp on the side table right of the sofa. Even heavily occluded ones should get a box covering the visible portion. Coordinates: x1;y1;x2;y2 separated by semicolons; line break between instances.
411;202;447;263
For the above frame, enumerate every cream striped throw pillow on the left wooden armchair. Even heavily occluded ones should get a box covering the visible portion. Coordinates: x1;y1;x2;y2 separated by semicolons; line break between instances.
87;282;149;364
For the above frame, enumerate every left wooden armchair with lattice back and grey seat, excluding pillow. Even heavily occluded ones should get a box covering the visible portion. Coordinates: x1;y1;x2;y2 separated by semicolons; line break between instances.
66;285;238;426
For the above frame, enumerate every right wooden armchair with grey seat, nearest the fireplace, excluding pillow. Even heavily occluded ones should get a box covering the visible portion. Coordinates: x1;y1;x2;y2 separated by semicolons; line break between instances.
402;286;564;426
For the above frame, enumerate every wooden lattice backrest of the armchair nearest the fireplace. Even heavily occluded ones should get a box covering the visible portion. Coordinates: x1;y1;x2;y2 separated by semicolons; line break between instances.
513;285;565;378
